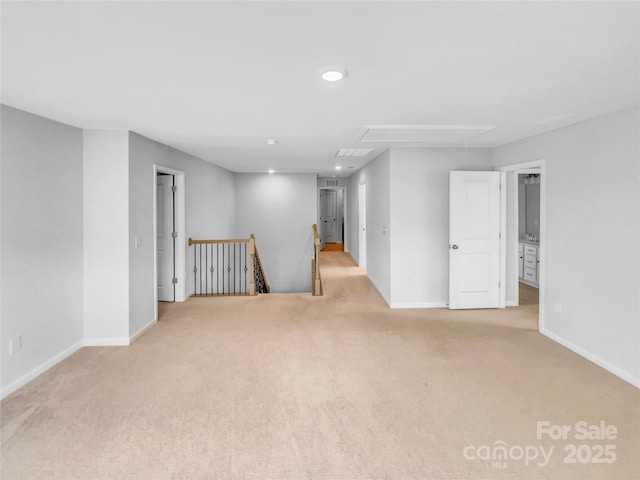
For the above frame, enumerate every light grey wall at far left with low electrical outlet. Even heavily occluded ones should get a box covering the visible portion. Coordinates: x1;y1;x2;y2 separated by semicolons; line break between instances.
0;105;83;397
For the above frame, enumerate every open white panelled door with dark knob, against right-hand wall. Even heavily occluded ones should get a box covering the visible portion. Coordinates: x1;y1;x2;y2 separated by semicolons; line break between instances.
449;172;501;309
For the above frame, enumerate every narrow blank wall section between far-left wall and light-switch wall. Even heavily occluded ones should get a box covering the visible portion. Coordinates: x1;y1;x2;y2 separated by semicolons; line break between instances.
83;130;129;345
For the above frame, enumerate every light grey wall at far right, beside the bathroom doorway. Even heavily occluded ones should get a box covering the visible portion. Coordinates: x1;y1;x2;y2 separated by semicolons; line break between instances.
494;108;640;385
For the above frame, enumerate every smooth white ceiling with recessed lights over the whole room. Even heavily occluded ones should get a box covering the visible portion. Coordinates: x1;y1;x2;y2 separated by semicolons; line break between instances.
1;1;640;175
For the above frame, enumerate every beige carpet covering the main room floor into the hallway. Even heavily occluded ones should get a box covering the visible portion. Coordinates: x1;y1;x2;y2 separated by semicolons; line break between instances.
0;252;640;480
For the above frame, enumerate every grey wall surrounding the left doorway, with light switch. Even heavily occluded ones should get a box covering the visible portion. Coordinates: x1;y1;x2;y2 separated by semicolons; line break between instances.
128;133;235;335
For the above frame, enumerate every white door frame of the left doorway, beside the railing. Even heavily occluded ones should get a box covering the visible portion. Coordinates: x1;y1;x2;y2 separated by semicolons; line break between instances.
153;164;187;321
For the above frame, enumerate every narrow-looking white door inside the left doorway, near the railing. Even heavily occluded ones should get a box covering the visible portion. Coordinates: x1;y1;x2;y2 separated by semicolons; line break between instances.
156;175;175;302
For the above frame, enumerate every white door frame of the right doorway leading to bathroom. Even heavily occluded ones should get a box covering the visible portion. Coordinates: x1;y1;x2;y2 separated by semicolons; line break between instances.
496;159;547;332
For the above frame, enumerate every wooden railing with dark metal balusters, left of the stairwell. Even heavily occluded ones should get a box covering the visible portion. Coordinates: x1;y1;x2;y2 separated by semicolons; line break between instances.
189;234;271;296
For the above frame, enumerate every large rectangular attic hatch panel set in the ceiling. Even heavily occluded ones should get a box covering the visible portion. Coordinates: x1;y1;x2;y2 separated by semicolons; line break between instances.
360;125;495;143
